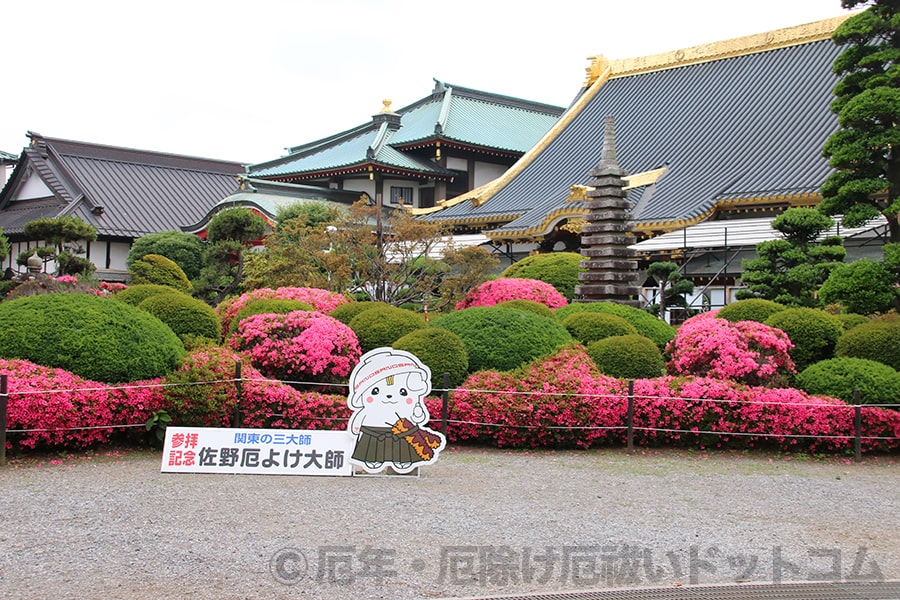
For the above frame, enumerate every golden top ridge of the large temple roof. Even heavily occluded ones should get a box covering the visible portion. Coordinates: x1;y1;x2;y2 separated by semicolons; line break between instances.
583;11;859;88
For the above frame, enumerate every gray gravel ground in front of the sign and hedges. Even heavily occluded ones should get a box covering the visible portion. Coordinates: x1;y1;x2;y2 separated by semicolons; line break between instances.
0;448;900;600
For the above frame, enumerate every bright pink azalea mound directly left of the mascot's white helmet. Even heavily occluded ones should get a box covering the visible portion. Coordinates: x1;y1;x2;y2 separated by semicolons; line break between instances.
228;310;360;383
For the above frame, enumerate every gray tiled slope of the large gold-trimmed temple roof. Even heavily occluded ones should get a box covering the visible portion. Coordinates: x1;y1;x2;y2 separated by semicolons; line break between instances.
426;25;841;238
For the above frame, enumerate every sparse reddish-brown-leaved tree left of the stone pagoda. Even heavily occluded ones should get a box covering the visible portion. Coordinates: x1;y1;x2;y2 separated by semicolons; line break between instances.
244;202;497;310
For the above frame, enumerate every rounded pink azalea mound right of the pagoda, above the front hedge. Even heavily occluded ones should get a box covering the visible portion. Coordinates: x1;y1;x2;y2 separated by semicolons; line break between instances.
666;313;796;385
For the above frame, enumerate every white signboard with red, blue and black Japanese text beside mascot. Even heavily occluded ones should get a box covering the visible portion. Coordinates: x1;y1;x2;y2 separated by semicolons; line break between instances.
161;427;356;476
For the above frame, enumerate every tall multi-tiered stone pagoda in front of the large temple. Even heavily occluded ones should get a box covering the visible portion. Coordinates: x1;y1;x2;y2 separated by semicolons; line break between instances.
575;115;641;307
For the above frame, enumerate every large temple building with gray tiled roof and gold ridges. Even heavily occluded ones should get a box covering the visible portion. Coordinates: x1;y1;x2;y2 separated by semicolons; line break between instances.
414;15;887;306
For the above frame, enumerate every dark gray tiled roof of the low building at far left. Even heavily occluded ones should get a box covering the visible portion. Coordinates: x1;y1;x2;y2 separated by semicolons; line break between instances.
0;134;243;238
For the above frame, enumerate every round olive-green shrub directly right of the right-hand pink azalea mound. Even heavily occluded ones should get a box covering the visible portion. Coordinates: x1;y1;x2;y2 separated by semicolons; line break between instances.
765;307;843;371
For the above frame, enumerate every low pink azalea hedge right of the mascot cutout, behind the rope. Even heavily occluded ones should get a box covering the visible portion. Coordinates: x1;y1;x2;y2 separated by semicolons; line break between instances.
428;346;900;451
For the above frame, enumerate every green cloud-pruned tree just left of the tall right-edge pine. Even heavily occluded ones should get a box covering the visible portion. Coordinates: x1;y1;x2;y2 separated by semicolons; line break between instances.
737;208;847;307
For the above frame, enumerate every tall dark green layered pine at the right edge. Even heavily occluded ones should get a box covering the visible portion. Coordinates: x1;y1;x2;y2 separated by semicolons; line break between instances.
819;0;900;242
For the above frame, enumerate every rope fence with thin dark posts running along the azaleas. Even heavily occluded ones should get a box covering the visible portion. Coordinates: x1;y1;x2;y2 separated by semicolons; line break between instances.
0;362;897;466
